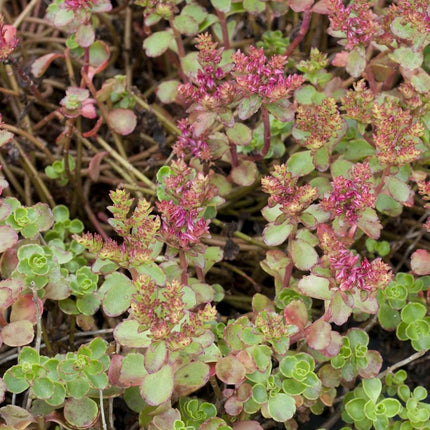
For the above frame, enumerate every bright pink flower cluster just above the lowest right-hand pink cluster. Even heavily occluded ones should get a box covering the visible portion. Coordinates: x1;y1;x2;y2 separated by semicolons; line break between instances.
321;163;376;224
